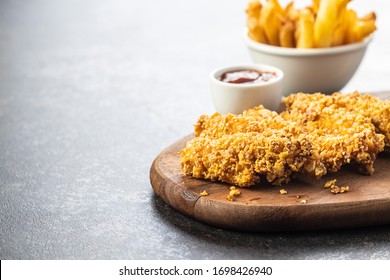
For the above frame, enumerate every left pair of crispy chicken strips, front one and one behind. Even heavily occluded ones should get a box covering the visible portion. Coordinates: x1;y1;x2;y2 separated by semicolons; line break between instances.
180;106;326;187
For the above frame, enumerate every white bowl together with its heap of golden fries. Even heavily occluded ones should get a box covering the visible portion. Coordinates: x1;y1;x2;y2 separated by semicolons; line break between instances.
244;0;376;95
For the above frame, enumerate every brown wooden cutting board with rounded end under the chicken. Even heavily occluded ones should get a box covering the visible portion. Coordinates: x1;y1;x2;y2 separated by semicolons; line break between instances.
150;92;390;231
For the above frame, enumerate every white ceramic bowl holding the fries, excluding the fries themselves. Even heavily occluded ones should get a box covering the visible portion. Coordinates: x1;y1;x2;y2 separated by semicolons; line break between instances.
245;35;372;96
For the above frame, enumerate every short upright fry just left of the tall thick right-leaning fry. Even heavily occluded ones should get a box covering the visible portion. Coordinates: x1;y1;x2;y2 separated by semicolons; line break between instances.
295;9;314;48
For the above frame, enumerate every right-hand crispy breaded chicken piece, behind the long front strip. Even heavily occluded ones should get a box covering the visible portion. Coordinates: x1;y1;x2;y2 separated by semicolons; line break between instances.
281;93;385;174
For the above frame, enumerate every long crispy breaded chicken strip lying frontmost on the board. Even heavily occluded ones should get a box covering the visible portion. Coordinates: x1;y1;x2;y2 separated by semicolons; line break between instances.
180;132;324;187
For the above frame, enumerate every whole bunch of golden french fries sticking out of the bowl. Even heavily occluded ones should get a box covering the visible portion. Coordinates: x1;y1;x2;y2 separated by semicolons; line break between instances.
246;0;377;48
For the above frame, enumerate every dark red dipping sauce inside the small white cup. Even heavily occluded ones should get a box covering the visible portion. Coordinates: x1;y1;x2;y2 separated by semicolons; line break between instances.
220;69;276;84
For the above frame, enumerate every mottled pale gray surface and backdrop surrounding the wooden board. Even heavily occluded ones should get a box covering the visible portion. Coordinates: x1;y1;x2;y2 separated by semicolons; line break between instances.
0;0;390;259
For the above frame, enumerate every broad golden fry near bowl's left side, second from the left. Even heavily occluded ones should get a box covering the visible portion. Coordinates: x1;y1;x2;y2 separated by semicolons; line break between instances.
260;0;283;46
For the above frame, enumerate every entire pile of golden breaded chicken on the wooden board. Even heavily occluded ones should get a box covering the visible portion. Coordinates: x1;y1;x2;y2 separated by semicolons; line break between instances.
179;92;390;187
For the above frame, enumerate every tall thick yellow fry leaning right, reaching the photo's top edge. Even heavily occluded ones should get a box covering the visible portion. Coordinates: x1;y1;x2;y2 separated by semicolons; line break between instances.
314;0;350;48
